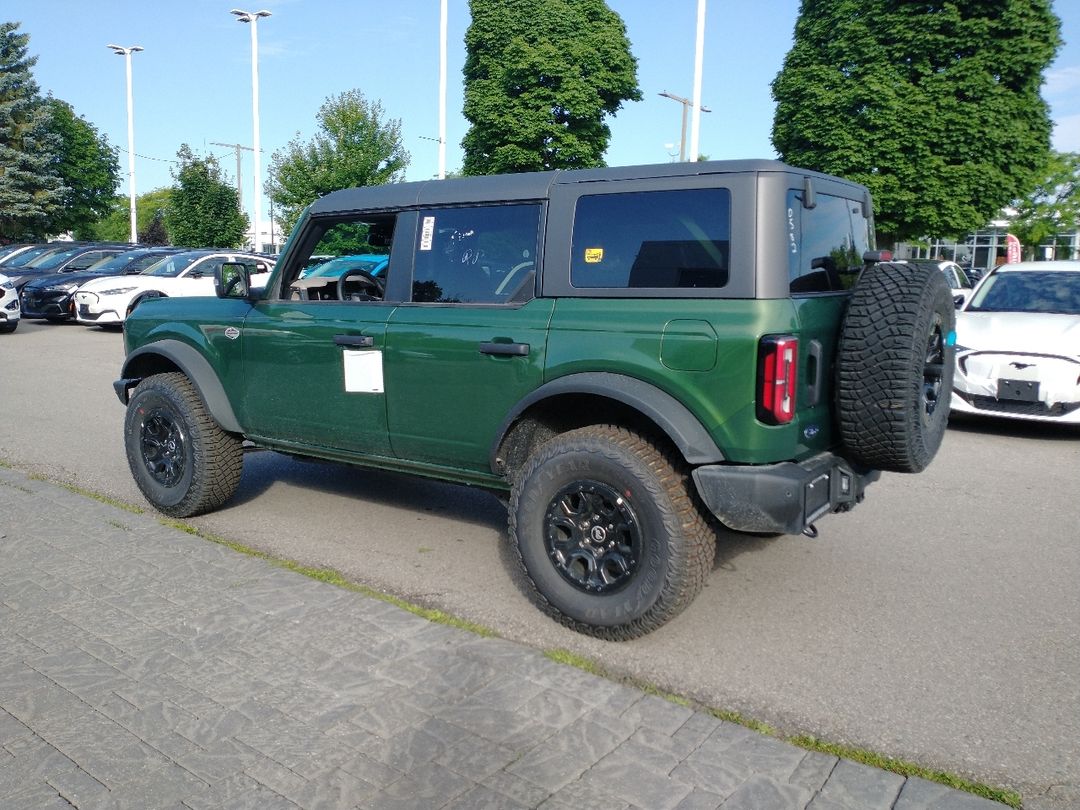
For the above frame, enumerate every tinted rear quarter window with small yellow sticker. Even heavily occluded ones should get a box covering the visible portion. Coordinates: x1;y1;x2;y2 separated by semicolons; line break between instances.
570;189;731;288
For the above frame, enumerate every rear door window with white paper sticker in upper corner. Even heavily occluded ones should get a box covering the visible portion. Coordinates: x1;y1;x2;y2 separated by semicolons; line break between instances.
413;203;540;303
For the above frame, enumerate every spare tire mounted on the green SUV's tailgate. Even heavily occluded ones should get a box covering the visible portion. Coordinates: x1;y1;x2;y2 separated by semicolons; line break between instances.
836;262;956;472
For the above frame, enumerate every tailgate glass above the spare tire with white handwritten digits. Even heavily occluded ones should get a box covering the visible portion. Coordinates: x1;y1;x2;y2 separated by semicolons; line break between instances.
787;189;869;293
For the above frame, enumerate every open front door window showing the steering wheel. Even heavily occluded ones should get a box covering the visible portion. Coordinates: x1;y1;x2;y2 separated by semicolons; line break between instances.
282;214;396;301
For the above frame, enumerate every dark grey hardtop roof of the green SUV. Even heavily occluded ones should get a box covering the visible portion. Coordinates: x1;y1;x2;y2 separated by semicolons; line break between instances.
310;160;862;215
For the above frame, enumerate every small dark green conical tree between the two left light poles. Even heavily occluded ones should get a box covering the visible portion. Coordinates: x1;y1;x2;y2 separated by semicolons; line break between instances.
165;144;247;247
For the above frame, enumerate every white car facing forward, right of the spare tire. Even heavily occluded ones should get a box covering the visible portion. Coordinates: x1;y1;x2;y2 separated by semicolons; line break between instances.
951;261;1080;424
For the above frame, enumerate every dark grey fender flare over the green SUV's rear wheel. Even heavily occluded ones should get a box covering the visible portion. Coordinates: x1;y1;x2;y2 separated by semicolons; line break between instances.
488;372;724;474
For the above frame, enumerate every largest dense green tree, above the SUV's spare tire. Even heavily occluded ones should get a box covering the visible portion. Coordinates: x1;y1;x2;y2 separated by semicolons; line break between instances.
772;0;1061;246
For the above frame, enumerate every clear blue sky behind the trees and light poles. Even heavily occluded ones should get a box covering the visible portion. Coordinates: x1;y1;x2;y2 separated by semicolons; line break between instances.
8;0;1080;228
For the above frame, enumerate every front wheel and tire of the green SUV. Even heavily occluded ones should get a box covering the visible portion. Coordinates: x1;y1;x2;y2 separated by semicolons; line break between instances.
124;373;244;517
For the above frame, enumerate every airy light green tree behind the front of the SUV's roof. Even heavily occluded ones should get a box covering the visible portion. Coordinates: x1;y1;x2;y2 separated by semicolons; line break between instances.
266;90;409;233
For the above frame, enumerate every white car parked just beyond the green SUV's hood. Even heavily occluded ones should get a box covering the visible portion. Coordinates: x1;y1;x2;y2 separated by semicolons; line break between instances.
75;251;273;326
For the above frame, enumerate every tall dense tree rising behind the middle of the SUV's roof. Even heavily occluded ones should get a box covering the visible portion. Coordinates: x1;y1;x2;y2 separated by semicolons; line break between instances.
461;0;642;175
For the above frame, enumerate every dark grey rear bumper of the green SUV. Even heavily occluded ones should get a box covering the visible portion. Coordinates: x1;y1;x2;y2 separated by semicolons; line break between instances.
693;453;881;535
